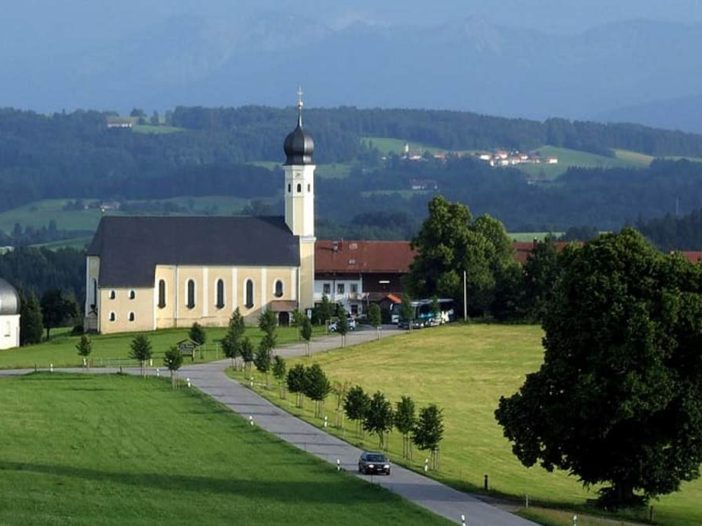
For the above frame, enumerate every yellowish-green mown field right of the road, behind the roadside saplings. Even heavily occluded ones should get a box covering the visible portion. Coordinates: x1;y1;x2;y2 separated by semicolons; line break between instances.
232;325;702;526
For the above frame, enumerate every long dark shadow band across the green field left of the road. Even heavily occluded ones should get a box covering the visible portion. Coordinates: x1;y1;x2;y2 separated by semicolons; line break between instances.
0;461;392;504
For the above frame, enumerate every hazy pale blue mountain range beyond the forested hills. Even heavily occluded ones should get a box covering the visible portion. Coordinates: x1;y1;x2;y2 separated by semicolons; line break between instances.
5;13;702;131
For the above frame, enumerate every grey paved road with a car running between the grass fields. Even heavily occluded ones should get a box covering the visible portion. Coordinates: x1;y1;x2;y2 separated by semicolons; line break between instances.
0;328;534;526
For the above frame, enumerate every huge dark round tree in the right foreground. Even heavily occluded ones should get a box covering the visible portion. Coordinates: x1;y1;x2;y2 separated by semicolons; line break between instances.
496;229;702;506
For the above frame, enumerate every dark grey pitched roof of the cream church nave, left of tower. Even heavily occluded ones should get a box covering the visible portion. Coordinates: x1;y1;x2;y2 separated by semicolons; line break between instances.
88;216;300;287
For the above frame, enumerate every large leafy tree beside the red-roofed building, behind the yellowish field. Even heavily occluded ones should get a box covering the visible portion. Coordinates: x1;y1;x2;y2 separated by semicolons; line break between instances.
408;196;516;313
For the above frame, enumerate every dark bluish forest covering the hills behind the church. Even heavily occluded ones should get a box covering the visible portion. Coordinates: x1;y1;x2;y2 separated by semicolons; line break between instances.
0;106;702;246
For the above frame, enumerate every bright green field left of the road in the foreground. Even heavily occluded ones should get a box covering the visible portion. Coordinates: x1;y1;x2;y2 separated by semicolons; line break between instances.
0;373;448;526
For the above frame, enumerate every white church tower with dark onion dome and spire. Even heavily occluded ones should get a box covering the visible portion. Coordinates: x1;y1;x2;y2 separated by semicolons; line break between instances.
283;90;316;309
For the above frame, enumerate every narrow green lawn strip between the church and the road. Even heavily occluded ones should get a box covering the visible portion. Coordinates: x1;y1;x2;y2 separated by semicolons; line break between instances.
0;327;324;369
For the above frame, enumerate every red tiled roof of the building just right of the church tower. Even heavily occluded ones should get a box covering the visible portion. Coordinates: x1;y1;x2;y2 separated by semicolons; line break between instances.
314;240;415;274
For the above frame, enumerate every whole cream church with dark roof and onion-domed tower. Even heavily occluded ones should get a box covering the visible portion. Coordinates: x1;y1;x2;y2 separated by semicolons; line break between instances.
84;99;316;334
